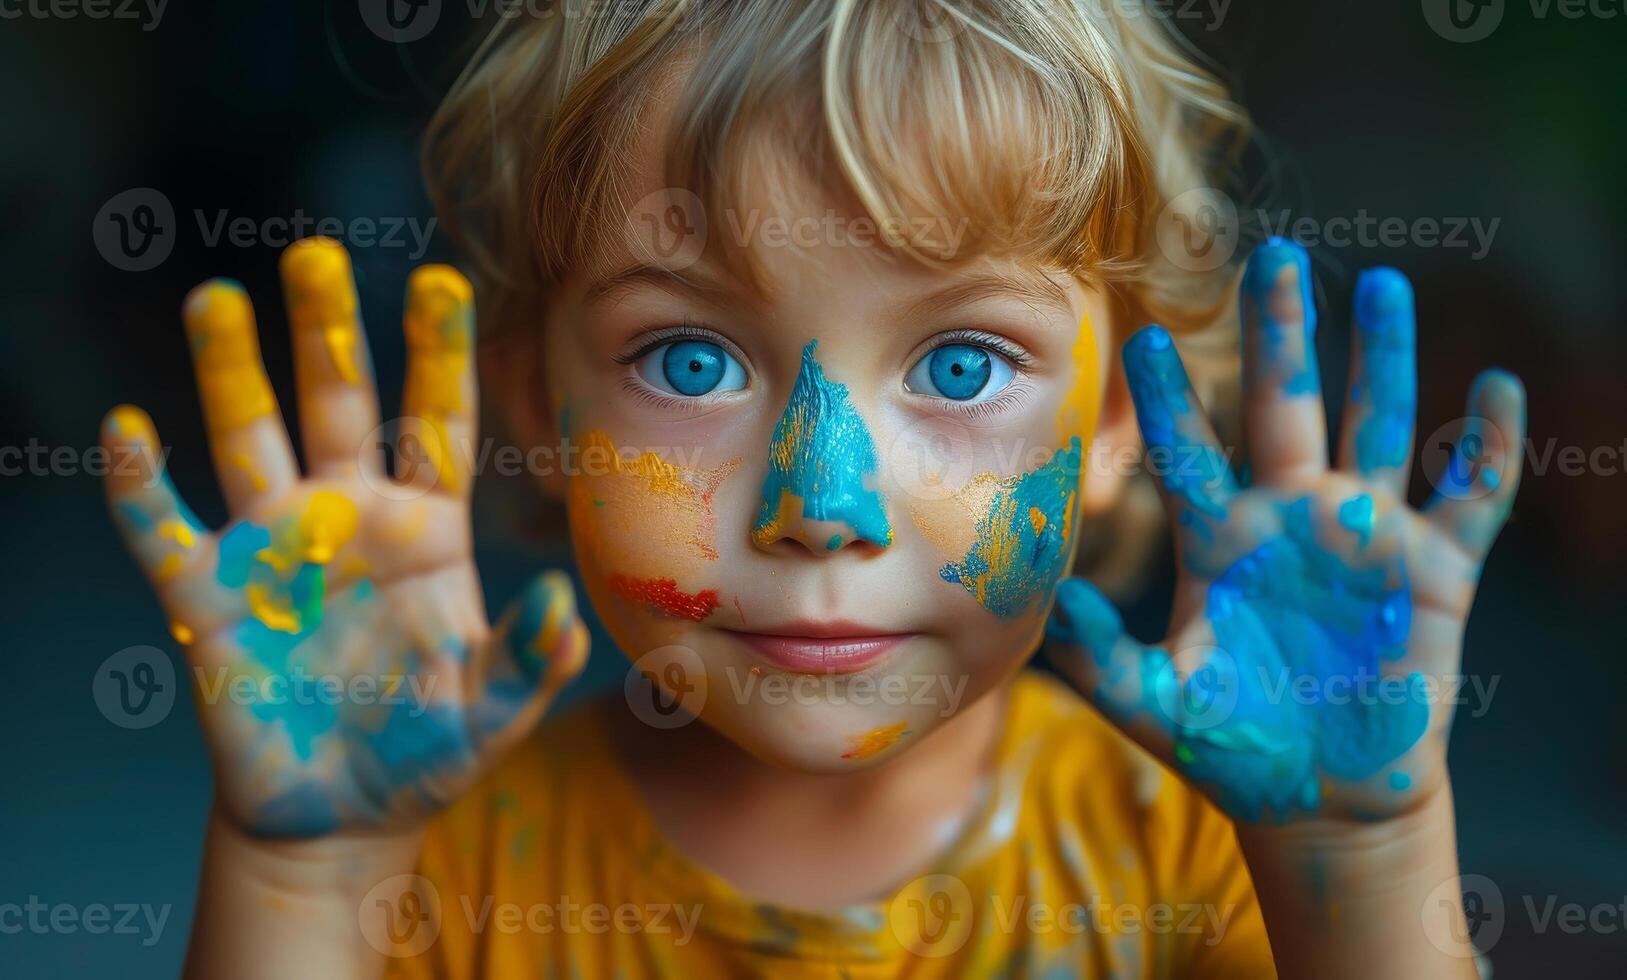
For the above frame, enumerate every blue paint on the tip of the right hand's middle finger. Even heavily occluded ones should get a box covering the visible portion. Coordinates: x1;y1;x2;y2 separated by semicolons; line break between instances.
1243;238;1321;396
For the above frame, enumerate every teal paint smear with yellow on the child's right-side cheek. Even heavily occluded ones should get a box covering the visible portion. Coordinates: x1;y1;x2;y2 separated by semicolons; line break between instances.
939;436;1084;619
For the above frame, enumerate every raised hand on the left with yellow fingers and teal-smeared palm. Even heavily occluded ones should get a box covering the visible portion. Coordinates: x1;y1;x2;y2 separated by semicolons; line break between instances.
103;239;587;838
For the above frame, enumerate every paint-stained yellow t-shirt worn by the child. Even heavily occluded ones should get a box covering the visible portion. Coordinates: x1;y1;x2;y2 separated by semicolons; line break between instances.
380;671;1274;980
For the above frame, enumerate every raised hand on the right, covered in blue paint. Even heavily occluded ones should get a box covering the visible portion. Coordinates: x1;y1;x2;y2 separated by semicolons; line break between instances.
1048;241;1524;824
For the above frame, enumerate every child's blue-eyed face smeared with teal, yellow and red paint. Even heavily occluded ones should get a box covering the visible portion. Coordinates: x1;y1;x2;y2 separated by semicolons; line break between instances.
530;133;1108;772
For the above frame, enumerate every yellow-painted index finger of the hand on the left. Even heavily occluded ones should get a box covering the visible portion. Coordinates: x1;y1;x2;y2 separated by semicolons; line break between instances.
395;265;475;497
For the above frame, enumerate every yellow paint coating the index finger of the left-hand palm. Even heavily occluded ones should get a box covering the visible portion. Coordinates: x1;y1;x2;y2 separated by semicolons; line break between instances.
402;265;475;492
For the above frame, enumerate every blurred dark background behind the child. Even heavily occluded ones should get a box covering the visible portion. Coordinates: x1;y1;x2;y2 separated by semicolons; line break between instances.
0;0;1627;977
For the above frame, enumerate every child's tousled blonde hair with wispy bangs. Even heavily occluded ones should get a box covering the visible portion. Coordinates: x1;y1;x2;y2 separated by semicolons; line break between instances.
423;0;1248;584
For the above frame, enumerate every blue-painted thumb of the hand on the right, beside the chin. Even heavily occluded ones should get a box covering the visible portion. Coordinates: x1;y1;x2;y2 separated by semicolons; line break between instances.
1045;578;1173;759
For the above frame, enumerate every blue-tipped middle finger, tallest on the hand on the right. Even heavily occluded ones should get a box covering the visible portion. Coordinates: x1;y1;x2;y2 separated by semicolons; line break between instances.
1243;238;1328;483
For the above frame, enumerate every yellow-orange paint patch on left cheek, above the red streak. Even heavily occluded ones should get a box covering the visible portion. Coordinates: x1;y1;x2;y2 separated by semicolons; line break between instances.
571;430;740;560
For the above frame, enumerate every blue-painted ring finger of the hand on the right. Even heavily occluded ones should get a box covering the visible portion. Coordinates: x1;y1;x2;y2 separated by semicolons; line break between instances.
1339;269;1419;497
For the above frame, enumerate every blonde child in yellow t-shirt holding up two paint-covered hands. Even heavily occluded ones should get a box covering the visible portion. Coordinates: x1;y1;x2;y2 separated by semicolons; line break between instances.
104;0;1524;977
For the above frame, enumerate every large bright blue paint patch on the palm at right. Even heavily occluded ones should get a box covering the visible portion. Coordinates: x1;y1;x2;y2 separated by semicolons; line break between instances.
1171;498;1429;820
